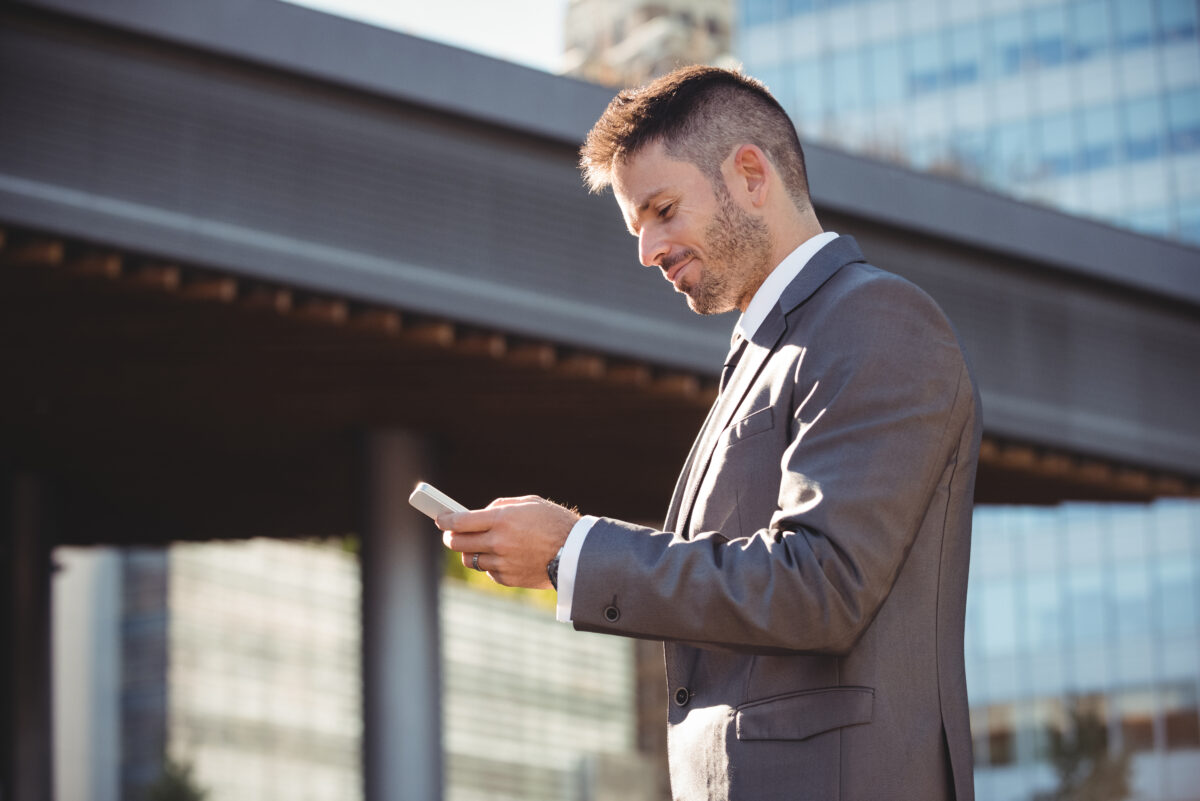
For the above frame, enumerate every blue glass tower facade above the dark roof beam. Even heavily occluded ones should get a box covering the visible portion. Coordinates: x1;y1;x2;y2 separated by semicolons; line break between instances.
736;0;1200;243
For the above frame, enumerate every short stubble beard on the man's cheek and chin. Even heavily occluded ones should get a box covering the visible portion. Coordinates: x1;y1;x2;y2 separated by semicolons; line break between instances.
679;186;772;314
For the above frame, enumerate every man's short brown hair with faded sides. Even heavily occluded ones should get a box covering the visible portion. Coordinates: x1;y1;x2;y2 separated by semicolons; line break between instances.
580;66;810;209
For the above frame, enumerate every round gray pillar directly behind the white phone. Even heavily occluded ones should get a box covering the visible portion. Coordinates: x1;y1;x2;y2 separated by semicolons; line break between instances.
361;432;443;801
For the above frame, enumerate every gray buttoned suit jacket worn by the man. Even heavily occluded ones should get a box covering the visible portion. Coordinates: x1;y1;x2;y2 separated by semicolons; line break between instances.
571;236;980;801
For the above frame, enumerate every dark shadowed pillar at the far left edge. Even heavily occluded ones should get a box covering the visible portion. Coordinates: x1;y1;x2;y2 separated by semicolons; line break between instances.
0;475;54;801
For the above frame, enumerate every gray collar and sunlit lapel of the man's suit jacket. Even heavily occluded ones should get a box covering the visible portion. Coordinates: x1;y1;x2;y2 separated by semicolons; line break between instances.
667;236;864;538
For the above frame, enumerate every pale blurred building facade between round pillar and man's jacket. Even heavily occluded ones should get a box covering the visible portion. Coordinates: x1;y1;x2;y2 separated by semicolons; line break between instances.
440;579;656;801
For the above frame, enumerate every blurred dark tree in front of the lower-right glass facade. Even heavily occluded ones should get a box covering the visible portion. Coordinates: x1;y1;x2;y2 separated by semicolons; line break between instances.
1034;698;1132;801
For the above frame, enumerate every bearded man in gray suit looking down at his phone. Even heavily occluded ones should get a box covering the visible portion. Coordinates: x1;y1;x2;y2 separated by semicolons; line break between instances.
438;67;980;801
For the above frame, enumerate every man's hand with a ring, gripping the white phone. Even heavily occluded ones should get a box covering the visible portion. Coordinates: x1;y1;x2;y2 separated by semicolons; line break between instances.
438;495;580;590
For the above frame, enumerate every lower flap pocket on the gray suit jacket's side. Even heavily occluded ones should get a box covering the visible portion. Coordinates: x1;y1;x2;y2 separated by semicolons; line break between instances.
736;687;875;740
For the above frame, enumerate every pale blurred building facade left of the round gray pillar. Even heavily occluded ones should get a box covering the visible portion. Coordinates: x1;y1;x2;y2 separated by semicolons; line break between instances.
166;540;362;801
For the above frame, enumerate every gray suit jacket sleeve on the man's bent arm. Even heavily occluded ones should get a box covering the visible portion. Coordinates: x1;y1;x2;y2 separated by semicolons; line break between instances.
572;272;977;654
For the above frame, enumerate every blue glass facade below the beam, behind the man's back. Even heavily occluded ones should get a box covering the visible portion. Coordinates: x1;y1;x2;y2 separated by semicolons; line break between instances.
965;501;1200;801
